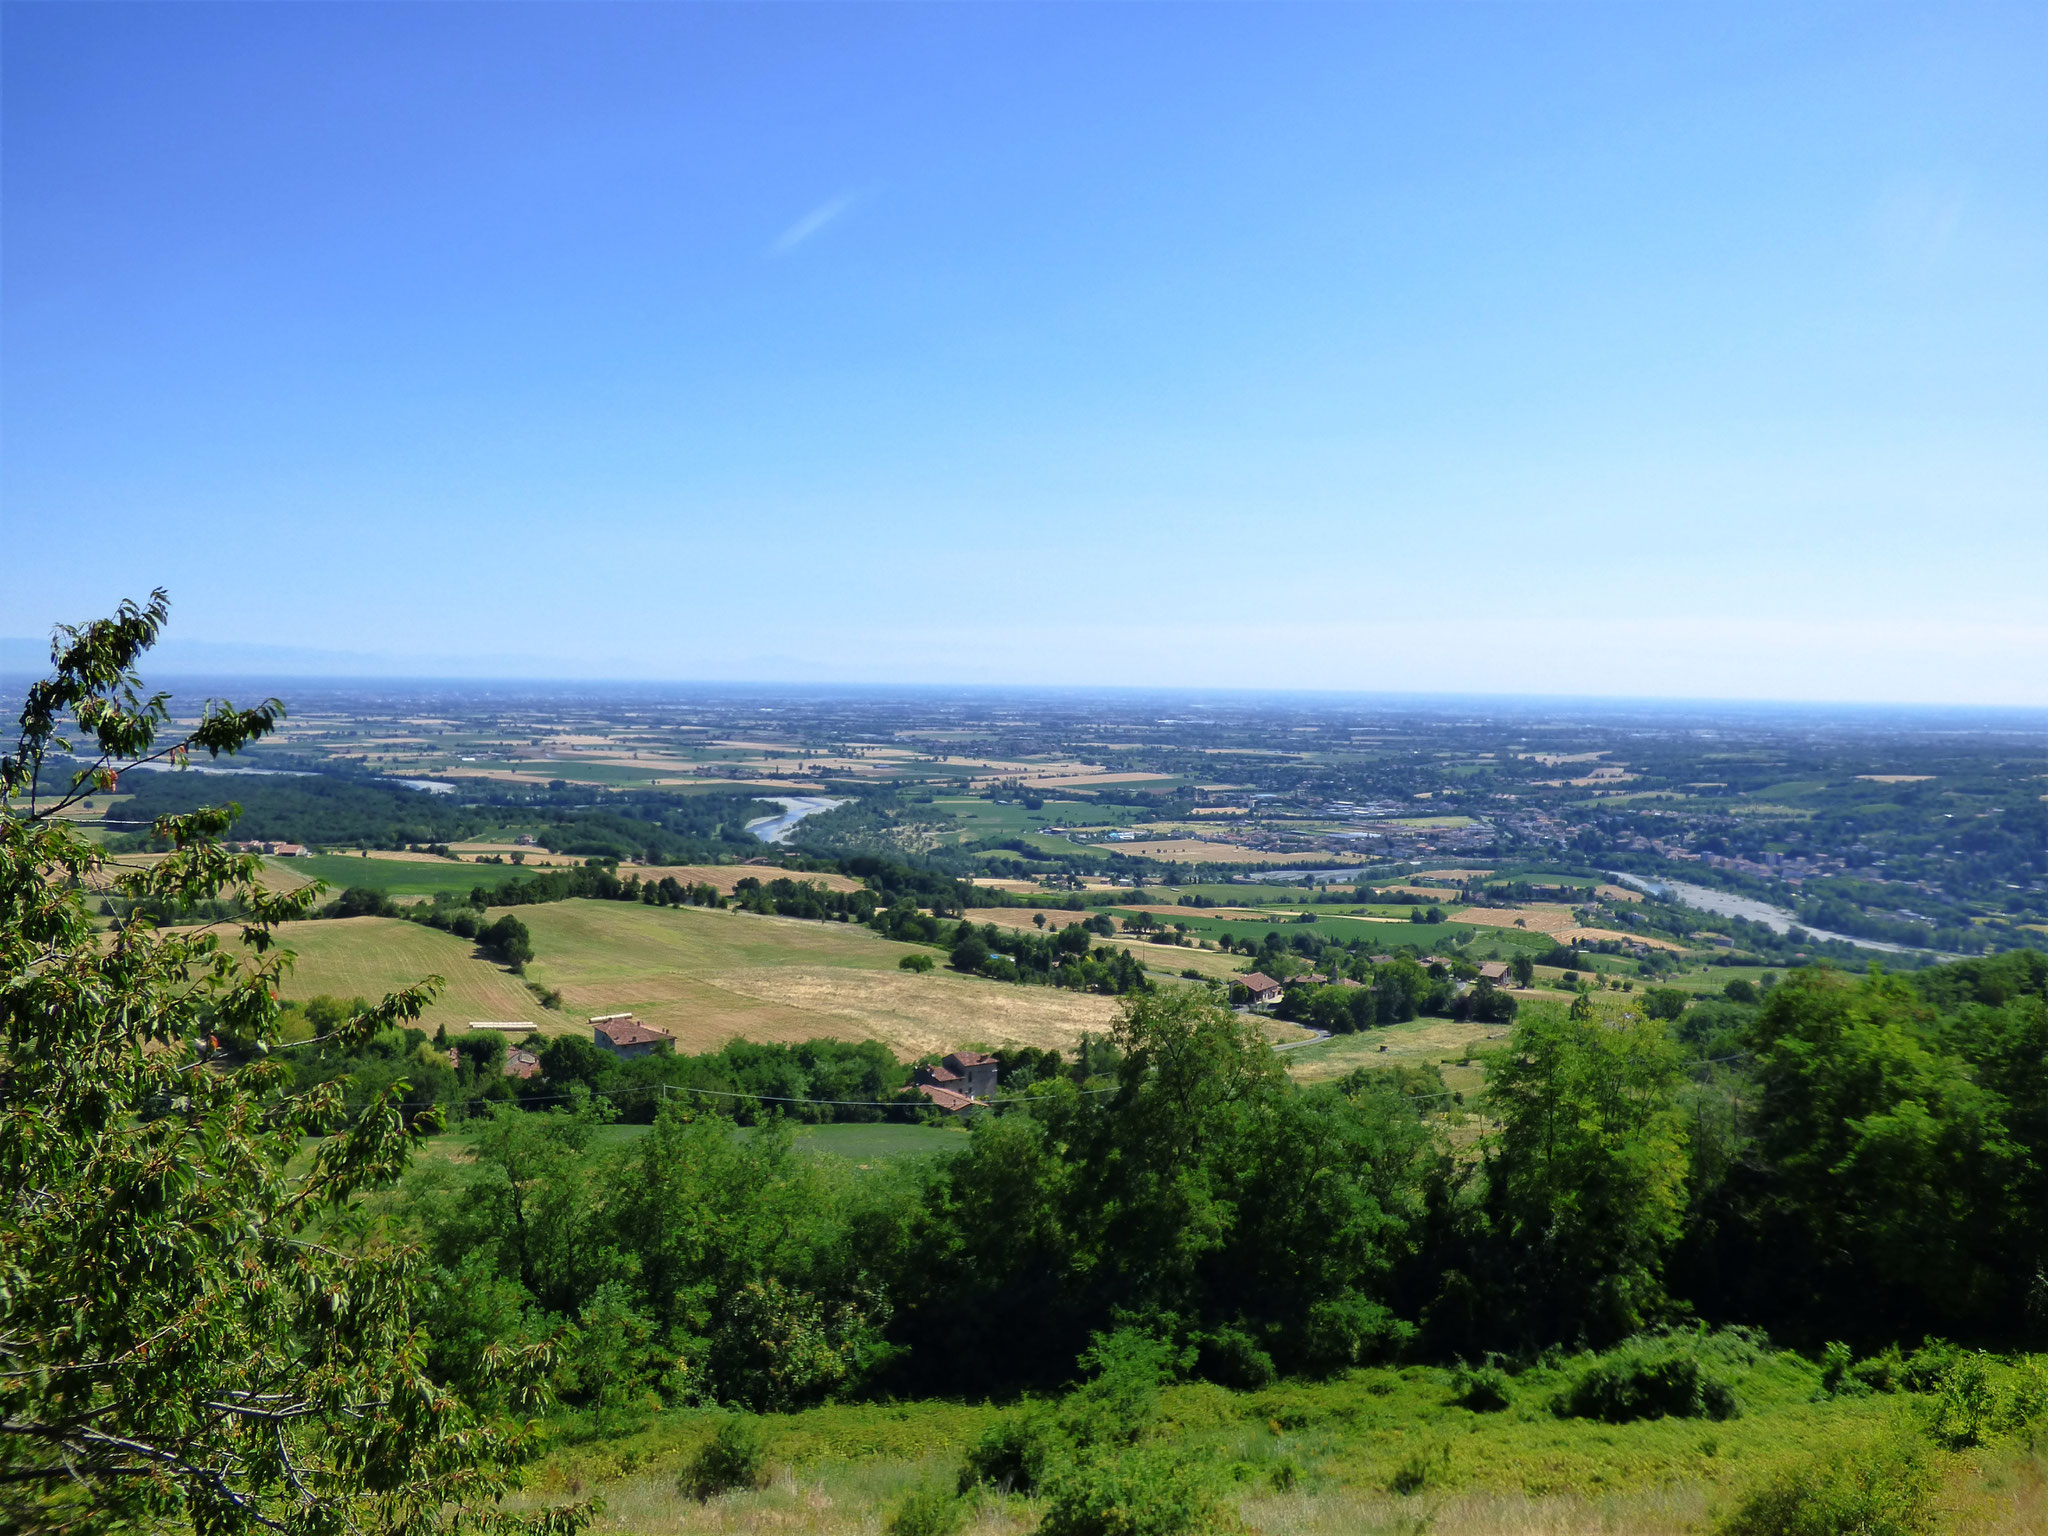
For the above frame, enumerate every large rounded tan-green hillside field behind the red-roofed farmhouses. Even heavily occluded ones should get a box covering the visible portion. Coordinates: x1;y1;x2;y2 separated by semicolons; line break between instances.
281;901;1116;1061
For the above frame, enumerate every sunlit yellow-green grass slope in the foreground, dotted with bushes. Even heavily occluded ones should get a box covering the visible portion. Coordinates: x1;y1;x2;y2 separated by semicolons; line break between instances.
507;1350;2048;1536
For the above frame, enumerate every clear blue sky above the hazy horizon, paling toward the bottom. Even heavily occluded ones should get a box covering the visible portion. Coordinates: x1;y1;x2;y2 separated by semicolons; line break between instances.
0;4;2048;705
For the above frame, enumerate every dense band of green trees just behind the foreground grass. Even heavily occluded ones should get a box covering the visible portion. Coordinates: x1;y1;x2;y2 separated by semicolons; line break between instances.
372;956;2048;1407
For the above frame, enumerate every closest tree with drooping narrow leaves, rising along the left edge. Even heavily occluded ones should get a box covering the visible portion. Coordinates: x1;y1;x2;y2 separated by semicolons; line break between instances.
0;592;584;1532
